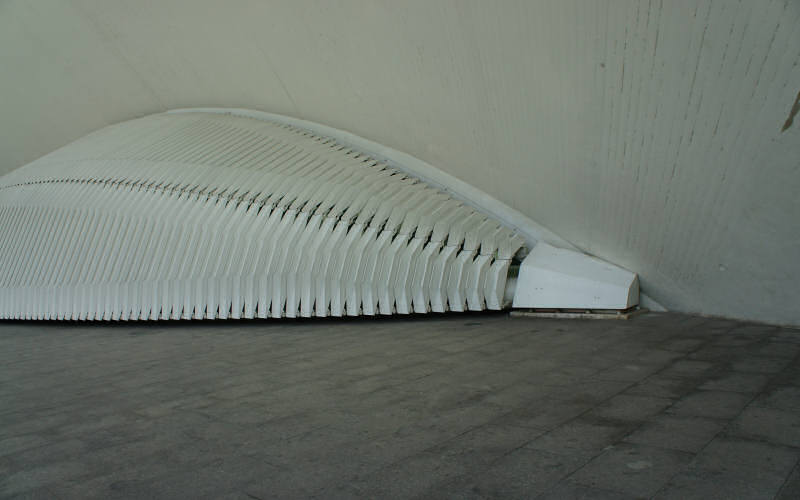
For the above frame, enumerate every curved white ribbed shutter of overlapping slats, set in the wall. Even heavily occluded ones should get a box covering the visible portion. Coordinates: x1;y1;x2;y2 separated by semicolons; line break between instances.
0;112;525;320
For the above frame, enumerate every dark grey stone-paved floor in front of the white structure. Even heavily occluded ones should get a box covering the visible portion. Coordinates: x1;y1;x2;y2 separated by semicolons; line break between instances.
0;314;800;499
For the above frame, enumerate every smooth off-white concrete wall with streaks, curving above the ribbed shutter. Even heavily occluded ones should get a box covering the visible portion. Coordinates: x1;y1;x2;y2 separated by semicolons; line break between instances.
0;0;800;324
